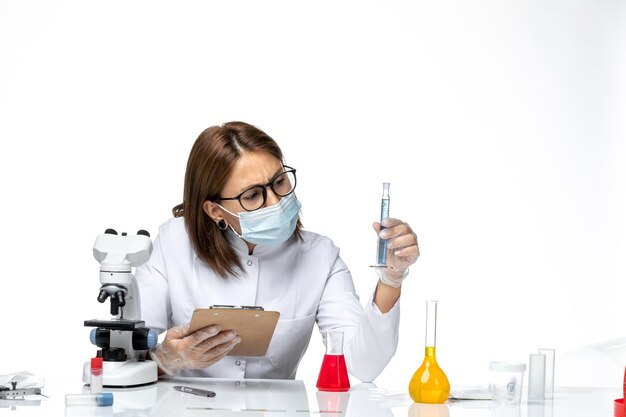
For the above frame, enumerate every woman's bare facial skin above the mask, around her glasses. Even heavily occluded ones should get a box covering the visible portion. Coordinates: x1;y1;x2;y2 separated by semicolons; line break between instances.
205;152;283;234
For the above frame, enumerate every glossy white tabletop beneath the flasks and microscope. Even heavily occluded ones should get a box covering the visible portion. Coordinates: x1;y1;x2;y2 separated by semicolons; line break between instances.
0;377;621;417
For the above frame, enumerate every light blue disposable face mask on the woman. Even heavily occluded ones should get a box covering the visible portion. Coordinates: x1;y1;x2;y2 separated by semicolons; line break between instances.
218;193;301;246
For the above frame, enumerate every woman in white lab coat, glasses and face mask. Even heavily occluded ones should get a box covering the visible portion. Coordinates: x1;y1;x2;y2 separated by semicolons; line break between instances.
136;122;419;381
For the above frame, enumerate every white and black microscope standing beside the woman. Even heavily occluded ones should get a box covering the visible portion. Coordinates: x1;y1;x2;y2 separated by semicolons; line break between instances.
83;229;158;387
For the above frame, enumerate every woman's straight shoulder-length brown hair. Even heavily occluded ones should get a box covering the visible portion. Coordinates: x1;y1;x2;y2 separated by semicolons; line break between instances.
172;122;302;278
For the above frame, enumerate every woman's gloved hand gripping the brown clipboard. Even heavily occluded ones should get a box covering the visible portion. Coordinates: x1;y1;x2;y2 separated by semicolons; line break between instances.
150;324;241;376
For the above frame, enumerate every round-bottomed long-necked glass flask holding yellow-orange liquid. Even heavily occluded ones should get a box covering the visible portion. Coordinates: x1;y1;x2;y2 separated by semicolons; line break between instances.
409;301;450;404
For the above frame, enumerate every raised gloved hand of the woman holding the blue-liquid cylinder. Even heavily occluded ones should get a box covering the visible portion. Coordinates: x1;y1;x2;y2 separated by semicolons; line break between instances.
374;218;420;282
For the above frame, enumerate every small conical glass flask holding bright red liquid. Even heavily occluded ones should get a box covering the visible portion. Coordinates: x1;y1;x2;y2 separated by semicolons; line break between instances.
317;330;350;392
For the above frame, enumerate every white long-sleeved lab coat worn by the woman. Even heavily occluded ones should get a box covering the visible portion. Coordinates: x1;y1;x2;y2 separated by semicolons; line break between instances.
136;217;400;381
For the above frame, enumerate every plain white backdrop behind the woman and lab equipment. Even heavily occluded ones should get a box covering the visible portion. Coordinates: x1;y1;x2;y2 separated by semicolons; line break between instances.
0;0;626;388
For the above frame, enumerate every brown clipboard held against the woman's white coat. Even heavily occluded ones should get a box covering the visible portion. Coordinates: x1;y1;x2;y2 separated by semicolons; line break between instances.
189;306;280;356
